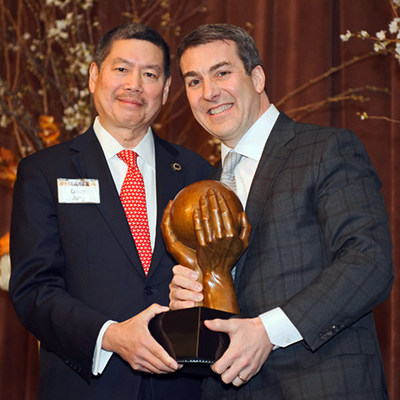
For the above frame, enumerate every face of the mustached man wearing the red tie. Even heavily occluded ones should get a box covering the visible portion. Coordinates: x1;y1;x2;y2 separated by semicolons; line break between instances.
89;39;170;147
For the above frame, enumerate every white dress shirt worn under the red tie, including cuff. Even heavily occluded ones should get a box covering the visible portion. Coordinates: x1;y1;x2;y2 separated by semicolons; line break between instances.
92;118;157;375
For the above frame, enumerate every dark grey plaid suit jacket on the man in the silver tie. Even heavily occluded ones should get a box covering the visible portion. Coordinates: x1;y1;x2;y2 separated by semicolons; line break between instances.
204;114;393;400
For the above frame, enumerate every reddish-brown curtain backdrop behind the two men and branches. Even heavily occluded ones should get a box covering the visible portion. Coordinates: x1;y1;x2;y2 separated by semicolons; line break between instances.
0;0;400;400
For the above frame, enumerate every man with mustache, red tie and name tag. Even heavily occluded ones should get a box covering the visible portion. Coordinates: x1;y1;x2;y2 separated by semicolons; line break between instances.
10;24;213;400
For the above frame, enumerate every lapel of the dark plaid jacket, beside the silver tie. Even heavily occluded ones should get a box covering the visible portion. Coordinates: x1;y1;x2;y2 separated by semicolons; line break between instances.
235;113;295;289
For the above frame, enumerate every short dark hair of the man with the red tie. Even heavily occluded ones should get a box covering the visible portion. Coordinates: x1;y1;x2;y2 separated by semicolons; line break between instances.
93;24;171;79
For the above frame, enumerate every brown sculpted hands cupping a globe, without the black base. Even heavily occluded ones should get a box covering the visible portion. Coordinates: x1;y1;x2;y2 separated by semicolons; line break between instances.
161;180;251;313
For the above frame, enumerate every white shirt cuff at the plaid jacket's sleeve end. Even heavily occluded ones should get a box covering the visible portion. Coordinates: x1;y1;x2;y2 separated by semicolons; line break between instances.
259;307;303;350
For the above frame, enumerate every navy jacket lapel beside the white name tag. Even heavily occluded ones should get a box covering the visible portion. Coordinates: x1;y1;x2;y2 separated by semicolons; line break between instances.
71;128;145;277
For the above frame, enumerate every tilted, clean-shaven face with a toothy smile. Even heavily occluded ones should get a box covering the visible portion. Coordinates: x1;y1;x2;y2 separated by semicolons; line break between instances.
180;40;269;148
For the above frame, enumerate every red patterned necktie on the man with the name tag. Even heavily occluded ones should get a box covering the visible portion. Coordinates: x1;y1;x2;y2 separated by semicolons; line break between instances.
118;150;152;275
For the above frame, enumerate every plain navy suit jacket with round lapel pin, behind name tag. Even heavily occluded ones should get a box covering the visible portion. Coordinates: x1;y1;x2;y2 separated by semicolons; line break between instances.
10;128;213;400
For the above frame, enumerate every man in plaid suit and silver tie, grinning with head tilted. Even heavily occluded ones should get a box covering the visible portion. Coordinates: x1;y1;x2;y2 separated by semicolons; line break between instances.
166;24;393;400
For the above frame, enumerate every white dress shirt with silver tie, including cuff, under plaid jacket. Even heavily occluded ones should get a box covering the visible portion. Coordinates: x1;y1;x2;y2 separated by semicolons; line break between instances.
221;104;303;349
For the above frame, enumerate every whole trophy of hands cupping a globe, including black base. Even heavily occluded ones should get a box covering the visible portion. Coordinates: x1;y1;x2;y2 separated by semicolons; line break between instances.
151;180;251;370
